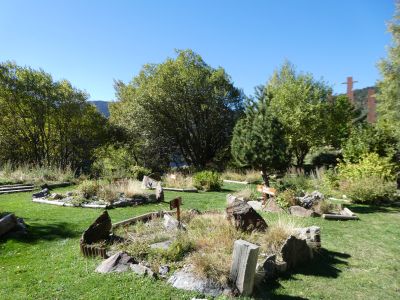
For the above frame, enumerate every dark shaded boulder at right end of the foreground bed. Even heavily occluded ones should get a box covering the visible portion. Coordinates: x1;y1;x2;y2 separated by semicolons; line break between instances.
280;235;313;269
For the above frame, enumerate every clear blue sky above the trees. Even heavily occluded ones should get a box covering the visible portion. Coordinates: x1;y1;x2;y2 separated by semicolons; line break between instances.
0;0;395;100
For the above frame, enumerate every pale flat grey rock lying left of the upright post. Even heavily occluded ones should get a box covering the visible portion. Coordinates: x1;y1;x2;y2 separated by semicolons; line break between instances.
168;266;224;297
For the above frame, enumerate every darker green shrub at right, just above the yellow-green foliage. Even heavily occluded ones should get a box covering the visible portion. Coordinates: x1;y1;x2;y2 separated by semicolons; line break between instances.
343;124;397;163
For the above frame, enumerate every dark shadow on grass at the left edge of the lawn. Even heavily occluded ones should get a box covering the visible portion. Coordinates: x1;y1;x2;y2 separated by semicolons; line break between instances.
0;222;81;244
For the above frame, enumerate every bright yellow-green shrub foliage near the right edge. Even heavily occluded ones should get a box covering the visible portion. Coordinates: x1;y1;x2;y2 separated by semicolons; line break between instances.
338;153;395;181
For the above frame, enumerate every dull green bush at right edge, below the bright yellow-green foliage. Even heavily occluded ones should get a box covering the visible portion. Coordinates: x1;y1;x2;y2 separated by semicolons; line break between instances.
340;176;398;205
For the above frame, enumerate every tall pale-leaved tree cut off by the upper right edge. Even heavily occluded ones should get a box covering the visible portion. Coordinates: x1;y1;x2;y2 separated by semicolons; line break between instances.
377;2;400;141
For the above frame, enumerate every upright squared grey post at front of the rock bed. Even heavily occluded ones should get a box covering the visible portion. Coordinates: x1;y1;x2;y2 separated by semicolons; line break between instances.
230;240;260;296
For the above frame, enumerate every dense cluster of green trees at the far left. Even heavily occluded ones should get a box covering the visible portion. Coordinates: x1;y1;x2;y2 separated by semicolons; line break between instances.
0;62;108;171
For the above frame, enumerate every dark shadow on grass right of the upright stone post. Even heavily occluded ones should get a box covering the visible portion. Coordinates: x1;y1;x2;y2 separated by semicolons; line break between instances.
253;249;350;299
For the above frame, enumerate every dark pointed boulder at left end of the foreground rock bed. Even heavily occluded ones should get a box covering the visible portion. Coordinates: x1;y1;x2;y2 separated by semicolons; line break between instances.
81;211;112;244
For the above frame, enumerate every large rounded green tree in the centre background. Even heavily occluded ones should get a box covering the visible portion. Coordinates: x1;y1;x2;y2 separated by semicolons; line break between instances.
110;50;244;168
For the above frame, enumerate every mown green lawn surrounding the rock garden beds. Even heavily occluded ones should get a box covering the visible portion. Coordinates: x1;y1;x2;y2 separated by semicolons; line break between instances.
0;184;400;299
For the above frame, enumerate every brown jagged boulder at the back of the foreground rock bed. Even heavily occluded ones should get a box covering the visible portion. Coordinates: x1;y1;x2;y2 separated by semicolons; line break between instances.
226;199;268;231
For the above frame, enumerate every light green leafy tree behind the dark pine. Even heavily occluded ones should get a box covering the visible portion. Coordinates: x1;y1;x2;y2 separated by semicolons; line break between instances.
258;62;353;167
